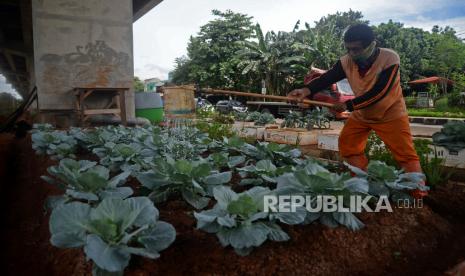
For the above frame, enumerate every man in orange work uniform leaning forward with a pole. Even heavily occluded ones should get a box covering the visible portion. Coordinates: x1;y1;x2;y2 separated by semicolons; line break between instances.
288;24;426;196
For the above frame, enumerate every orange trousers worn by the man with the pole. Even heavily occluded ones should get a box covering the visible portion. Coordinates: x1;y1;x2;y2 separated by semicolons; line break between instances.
339;116;422;172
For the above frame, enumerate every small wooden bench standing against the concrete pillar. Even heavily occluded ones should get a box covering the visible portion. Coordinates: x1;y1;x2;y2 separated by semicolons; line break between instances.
73;87;129;125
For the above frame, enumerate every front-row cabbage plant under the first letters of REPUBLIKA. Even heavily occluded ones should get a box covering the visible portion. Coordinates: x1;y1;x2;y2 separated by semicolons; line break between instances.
194;186;305;256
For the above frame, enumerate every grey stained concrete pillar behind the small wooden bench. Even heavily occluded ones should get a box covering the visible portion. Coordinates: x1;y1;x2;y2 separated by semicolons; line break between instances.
32;0;134;118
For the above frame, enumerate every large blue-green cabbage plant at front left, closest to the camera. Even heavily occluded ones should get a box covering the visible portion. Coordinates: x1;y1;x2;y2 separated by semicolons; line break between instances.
50;197;176;275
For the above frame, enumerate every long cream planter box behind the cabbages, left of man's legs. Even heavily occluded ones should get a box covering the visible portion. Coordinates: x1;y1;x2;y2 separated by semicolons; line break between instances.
265;128;320;146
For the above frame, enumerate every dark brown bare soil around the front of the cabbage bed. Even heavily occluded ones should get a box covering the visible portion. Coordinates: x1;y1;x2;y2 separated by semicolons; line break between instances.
0;135;465;275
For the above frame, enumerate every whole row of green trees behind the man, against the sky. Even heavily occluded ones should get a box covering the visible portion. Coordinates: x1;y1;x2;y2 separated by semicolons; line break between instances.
172;10;465;95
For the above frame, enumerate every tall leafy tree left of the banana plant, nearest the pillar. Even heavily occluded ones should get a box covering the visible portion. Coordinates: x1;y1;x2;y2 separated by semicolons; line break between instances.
169;10;253;89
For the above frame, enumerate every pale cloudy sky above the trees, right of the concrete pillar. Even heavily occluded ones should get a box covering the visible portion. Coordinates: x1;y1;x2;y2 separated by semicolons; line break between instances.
133;0;465;80
